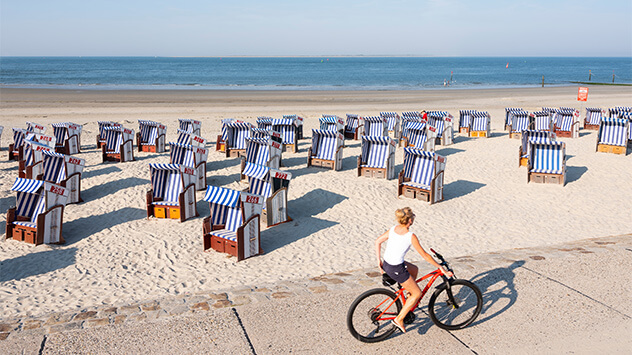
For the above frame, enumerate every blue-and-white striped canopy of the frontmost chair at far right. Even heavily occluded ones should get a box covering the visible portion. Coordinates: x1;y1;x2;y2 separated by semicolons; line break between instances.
529;139;566;174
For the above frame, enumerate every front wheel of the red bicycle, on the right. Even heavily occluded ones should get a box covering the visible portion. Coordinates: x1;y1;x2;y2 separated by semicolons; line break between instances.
428;280;483;330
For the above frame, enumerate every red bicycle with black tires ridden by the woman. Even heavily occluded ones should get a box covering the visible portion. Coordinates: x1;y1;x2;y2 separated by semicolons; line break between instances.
347;249;483;343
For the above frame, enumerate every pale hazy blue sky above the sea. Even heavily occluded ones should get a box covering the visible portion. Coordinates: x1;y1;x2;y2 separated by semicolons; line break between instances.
0;0;632;57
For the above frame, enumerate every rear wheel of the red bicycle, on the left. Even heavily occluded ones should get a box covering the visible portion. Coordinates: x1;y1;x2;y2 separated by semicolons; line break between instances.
347;288;402;343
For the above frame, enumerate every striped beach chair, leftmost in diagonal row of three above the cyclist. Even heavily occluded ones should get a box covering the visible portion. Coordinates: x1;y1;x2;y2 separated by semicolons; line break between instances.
307;129;344;171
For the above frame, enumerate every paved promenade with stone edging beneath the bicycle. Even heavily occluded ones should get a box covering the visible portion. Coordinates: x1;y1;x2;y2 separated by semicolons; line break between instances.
0;235;632;354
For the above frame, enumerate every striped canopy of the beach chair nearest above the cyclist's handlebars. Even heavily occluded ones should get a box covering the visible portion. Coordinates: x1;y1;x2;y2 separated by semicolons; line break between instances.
404;148;445;190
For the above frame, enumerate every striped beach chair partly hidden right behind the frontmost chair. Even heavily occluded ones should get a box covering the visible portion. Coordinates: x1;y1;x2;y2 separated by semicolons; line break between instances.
244;163;292;227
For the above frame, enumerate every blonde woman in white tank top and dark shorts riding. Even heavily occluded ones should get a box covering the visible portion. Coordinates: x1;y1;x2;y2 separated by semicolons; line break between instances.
375;207;454;333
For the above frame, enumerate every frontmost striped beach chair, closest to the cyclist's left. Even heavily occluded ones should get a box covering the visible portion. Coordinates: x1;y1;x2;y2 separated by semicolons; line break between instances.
202;186;264;261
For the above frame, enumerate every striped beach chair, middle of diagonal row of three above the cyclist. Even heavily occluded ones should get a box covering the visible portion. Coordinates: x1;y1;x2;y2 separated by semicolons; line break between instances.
358;136;396;180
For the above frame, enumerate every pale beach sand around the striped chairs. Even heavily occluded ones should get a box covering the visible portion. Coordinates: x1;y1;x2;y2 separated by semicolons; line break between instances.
0;87;632;319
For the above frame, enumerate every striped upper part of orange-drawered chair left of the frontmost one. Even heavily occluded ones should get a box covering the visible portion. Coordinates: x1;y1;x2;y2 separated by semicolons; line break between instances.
149;164;195;206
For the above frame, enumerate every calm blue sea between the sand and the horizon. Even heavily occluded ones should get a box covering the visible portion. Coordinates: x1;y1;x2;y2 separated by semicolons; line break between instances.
0;57;632;90
